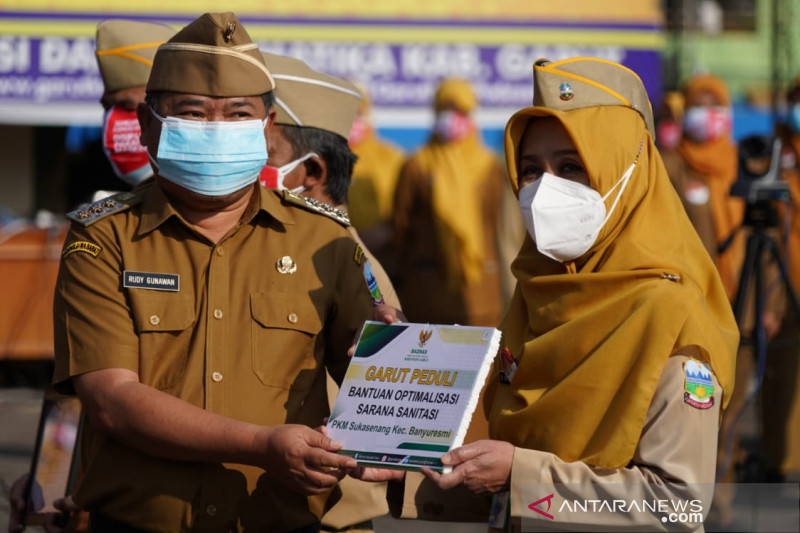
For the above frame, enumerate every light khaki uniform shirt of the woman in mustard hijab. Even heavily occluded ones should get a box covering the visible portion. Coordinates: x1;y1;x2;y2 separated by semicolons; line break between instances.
389;355;723;531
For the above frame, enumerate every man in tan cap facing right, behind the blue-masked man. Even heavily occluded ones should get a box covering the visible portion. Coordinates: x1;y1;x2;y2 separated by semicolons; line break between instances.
262;53;400;531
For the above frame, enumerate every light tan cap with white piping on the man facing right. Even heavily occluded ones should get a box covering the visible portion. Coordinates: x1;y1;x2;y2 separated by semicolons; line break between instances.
262;52;361;139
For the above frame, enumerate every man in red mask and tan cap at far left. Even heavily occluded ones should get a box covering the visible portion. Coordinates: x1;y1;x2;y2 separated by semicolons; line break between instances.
67;19;175;208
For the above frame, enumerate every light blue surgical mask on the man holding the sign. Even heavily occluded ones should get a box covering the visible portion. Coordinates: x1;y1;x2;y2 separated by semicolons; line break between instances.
148;109;267;196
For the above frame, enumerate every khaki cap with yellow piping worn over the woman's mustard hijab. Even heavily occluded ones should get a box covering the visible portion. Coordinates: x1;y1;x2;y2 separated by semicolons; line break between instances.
533;57;656;140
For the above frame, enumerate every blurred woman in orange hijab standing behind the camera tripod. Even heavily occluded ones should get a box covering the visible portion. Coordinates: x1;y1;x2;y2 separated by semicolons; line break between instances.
662;74;783;526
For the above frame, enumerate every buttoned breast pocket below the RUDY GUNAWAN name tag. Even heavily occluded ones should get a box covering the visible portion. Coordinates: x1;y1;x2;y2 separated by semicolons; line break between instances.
131;290;196;390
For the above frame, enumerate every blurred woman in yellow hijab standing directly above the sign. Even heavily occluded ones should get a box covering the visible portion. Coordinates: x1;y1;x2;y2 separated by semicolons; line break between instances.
392;78;504;326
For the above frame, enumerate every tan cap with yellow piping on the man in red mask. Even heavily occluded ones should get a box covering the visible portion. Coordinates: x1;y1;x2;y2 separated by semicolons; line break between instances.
95;19;175;92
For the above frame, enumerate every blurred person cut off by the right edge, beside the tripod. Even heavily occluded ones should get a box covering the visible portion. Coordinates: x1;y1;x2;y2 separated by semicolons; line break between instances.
761;77;800;482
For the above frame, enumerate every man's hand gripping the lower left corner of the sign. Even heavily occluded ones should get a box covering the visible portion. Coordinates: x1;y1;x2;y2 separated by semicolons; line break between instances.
257;424;356;495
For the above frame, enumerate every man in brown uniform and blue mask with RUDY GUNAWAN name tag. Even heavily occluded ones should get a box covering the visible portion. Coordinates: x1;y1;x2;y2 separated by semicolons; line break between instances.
54;13;382;532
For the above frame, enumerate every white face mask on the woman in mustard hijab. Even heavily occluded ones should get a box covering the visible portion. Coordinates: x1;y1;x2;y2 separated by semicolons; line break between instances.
519;163;636;263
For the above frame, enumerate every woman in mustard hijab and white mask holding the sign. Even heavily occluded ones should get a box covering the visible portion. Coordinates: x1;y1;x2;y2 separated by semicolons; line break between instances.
364;58;738;531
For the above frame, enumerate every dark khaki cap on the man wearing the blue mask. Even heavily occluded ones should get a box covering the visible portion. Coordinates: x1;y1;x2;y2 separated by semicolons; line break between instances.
147;12;275;97
